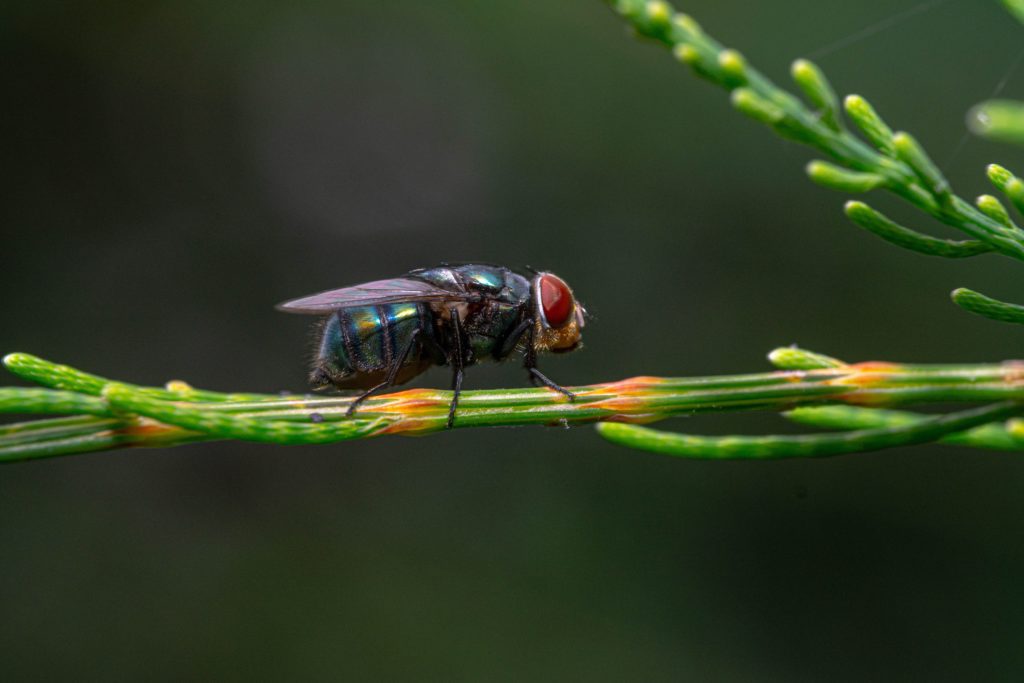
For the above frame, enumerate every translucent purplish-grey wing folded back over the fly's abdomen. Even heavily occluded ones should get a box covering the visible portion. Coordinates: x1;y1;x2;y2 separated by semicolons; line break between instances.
276;278;472;315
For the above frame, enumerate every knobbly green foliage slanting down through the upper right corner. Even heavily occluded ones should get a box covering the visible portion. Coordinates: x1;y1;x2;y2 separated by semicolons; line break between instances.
610;0;1024;323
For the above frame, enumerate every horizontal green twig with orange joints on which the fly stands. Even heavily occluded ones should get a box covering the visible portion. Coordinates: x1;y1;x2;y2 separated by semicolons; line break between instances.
0;347;1024;462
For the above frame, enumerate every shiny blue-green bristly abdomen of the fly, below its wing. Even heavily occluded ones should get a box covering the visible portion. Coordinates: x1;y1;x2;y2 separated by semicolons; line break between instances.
310;303;433;388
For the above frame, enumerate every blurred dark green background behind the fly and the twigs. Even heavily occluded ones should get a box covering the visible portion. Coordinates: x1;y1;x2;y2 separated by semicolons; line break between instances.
0;0;1024;681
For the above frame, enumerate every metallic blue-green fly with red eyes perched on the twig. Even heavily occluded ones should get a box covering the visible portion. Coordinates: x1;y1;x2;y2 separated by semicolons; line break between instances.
278;264;586;428
